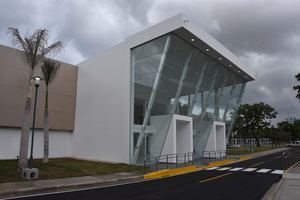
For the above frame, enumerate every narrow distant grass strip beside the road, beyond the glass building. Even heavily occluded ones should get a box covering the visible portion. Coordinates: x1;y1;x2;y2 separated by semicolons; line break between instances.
227;145;282;155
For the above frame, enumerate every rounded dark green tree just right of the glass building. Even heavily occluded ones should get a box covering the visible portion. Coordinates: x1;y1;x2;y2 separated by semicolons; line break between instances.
236;102;277;146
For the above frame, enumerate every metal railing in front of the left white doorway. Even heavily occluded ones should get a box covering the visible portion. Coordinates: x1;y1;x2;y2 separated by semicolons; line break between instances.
144;152;194;171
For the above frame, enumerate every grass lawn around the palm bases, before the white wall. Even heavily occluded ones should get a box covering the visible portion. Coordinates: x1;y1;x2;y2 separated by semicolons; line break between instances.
0;158;144;183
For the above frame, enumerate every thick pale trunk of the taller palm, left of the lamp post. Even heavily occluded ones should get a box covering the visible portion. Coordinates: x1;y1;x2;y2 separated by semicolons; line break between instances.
19;78;32;168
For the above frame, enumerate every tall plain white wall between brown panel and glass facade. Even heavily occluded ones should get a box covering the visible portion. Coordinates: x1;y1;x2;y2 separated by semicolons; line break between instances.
72;43;131;163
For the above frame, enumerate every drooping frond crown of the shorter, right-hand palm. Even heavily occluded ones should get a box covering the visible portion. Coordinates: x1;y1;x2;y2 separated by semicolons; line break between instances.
41;58;60;86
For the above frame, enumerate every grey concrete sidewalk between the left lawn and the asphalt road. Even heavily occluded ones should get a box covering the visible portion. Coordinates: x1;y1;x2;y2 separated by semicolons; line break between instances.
0;172;143;199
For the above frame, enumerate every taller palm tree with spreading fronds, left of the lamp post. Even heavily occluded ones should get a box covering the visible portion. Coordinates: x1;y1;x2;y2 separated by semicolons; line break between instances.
8;28;62;168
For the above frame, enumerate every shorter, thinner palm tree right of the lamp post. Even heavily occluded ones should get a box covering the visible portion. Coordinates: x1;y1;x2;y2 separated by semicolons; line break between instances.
41;59;60;163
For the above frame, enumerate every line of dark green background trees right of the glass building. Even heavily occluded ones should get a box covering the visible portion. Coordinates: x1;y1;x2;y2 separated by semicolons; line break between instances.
234;102;300;146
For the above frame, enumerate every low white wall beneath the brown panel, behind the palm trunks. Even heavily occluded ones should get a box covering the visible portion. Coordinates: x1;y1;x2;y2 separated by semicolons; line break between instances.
0;128;72;159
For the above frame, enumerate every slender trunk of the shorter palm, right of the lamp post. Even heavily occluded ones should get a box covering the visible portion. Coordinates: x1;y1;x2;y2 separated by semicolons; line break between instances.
43;86;49;163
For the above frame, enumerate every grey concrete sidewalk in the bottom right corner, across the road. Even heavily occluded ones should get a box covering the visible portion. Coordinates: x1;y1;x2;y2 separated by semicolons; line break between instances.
263;161;300;200
